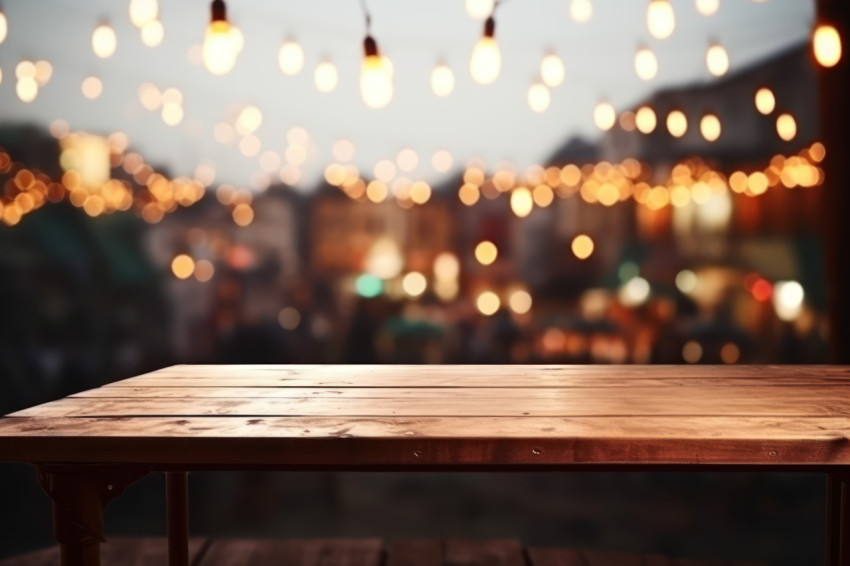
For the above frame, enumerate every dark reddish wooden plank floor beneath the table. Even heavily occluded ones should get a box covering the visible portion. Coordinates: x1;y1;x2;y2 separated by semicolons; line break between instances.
0;538;760;566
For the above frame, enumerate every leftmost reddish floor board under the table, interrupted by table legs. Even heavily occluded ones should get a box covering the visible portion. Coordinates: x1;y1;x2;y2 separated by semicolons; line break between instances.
0;537;207;566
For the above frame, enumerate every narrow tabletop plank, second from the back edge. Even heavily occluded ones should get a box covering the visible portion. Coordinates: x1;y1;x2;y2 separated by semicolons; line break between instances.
69;386;850;401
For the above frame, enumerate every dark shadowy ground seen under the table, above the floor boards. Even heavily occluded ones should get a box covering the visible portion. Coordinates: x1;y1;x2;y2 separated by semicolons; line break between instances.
0;465;825;566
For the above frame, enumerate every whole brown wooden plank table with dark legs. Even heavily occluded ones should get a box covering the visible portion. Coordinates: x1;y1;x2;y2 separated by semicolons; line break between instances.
0;365;850;566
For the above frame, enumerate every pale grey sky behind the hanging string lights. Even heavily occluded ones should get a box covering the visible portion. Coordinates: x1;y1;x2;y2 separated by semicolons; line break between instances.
0;0;814;190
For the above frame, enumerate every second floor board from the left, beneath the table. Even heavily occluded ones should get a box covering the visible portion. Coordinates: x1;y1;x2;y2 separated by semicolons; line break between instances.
198;539;381;566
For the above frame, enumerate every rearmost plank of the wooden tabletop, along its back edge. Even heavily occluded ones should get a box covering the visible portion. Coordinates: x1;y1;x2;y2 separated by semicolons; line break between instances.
107;365;850;387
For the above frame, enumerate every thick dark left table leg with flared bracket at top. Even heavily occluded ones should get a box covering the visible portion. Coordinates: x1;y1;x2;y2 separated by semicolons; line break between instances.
37;464;151;566
